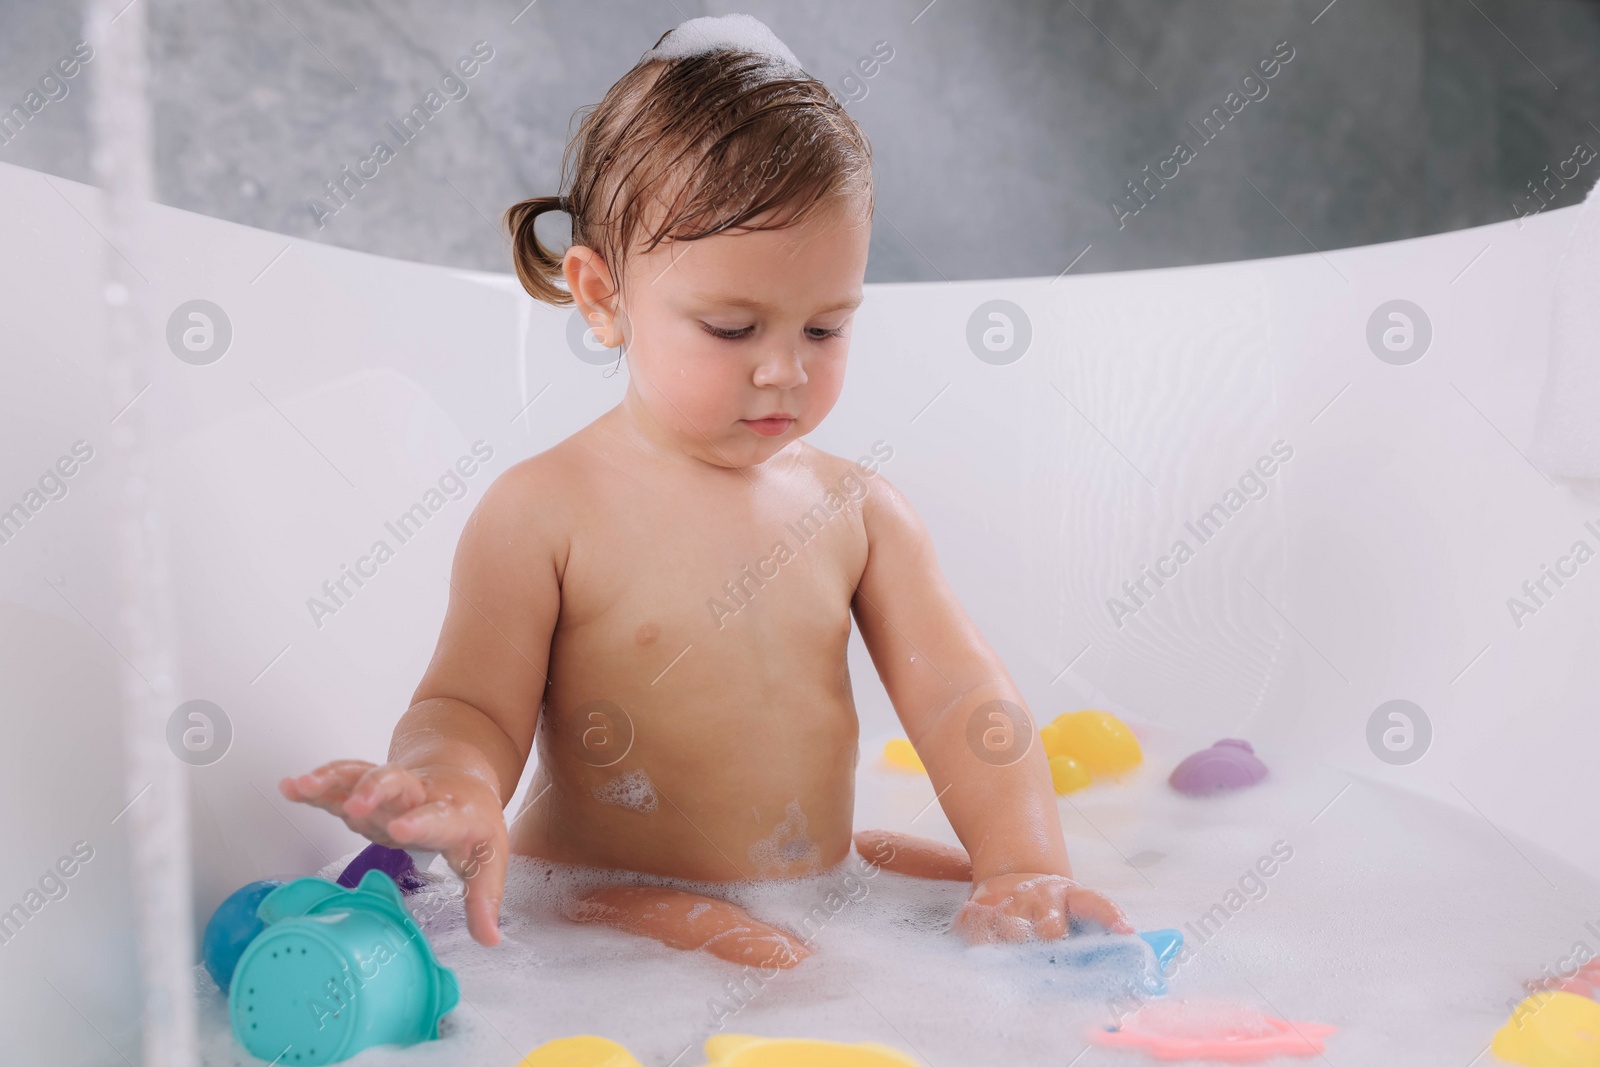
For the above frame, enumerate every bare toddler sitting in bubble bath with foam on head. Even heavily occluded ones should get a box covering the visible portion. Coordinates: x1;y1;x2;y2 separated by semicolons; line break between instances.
280;16;1131;966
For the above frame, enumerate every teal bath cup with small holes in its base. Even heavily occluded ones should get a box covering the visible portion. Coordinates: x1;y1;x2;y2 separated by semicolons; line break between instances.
227;870;461;1064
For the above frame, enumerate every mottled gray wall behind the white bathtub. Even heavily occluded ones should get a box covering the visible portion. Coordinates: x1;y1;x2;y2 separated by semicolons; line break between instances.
0;0;1600;282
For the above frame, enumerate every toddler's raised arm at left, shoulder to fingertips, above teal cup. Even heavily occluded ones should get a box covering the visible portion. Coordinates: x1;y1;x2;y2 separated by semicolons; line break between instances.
278;456;566;945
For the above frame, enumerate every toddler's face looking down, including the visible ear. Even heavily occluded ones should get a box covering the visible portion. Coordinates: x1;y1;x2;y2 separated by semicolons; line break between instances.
566;200;870;467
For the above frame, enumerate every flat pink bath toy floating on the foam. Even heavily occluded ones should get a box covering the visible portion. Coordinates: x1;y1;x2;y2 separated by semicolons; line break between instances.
1085;1001;1338;1064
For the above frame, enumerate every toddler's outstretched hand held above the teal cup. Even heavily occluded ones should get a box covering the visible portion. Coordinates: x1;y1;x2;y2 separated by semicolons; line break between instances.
278;760;509;945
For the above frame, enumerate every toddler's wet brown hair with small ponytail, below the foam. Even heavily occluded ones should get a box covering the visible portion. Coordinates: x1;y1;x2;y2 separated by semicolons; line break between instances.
504;30;875;306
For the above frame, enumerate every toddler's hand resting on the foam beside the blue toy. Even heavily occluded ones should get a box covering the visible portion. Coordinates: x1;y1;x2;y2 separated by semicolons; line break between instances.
950;873;1133;944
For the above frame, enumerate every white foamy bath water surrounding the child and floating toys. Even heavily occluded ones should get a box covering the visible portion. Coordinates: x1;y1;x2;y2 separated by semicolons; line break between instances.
195;731;1600;1067
